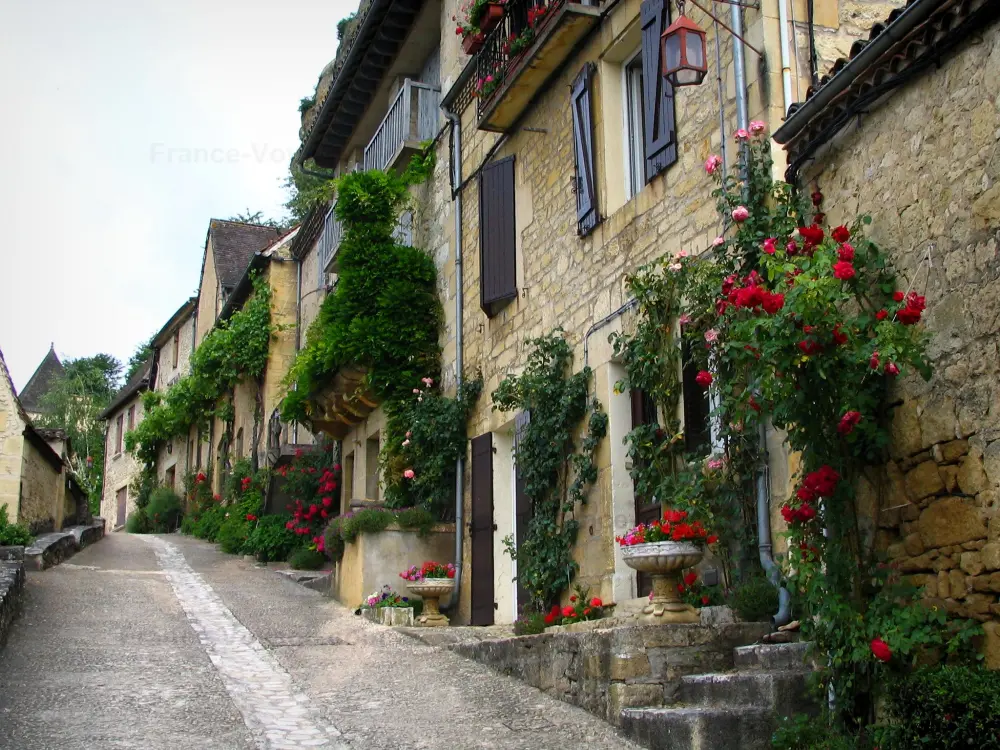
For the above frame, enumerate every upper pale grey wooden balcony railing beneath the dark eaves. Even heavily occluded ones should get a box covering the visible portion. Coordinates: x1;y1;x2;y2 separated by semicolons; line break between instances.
364;78;441;169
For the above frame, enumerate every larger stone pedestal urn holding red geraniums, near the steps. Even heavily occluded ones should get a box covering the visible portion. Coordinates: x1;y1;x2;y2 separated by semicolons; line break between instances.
622;542;705;625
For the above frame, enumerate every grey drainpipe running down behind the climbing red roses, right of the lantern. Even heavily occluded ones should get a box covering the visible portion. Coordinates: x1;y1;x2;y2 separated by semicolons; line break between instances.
730;0;791;626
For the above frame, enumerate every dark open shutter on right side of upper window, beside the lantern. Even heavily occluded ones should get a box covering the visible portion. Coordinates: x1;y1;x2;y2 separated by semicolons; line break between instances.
639;0;677;182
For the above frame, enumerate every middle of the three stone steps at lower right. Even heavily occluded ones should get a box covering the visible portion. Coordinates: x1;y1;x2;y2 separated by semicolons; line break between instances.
677;670;815;716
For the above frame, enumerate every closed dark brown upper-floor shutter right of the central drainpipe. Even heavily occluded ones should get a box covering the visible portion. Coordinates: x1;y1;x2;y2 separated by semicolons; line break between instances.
479;156;517;317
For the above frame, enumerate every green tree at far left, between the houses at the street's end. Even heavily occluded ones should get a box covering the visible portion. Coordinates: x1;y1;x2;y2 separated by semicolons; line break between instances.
37;354;122;513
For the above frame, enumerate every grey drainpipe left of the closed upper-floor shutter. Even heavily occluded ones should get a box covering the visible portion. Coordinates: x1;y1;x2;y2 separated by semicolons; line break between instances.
444;110;465;611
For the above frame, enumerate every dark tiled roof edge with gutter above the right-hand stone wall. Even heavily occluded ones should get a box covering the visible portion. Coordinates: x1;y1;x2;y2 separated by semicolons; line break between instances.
774;0;1000;181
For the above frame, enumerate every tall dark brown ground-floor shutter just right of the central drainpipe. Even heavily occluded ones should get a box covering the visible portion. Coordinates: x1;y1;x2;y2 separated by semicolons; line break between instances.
469;432;494;625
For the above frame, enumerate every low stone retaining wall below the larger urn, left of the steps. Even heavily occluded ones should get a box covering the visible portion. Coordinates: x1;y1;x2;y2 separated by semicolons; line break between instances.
451;620;770;724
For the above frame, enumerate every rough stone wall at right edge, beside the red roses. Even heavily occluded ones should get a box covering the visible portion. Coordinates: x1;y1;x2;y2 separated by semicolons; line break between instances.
804;16;1000;652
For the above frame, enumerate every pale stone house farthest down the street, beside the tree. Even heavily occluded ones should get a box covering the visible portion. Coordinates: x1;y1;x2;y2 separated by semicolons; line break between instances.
98;362;151;529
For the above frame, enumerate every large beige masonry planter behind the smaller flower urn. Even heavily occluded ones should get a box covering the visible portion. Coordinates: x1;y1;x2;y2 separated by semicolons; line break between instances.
330;523;455;607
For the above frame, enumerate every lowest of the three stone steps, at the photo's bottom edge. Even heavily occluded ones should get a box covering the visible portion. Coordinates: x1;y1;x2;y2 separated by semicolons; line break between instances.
621;706;775;750
